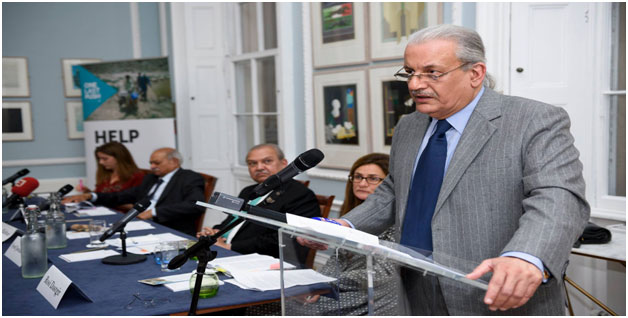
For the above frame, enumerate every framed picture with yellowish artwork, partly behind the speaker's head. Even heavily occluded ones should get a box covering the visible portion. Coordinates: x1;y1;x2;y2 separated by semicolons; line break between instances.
369;2;443;60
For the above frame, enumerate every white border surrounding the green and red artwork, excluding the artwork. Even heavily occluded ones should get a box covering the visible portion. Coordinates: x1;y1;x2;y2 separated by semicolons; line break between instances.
310;2;366;68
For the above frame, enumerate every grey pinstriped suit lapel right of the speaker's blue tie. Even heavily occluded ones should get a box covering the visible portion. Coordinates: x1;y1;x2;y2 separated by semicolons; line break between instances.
434;88;501;216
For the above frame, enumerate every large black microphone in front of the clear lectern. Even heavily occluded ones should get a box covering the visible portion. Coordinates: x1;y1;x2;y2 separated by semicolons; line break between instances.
253;148;325;196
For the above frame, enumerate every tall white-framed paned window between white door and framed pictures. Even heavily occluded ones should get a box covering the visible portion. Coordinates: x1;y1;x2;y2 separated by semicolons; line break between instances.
230;2;279;165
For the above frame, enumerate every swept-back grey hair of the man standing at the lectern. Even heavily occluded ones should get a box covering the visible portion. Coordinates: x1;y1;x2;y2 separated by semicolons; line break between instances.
408;24;495;88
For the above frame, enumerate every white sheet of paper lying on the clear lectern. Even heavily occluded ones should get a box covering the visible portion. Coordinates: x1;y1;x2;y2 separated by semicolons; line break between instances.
286;213;379;245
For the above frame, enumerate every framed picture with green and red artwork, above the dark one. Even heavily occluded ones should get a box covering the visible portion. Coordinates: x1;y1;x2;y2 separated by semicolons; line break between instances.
310;2;366;67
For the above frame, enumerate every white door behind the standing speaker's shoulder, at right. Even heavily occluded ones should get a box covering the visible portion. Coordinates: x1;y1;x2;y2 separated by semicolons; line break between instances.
510;2;594;180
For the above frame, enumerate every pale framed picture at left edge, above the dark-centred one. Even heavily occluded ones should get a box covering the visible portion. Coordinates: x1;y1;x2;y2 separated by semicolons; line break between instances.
2;57;31;97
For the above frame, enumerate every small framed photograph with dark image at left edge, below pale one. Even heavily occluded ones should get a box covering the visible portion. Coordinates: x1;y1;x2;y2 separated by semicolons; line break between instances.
2;101;33;141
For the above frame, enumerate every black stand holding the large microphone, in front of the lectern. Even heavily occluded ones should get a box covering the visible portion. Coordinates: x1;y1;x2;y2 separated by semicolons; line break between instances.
168;218;244;316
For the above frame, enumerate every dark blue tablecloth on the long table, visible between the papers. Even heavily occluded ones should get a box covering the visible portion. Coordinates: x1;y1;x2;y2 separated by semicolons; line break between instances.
2;201;328;316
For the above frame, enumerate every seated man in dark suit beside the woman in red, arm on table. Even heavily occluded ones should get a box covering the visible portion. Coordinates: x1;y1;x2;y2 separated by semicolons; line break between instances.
63;148;205;235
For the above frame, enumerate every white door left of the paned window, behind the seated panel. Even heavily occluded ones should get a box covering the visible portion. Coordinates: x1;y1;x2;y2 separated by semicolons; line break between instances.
172;3;233;225
